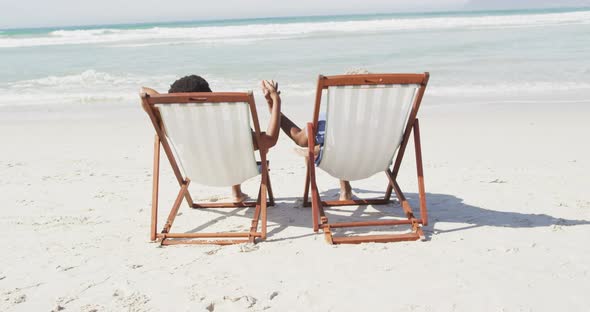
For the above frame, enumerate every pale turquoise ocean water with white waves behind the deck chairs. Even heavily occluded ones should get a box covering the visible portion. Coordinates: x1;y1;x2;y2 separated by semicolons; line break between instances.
0;9;590;107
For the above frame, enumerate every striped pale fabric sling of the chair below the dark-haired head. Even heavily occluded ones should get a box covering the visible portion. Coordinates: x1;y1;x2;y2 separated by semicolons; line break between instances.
156;103;259;186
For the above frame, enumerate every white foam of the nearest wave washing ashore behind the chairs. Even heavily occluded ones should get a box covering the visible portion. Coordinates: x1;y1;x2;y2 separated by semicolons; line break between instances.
0;69;590;106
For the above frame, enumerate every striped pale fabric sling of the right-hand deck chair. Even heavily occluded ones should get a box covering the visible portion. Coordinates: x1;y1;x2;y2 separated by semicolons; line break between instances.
319;84;420;181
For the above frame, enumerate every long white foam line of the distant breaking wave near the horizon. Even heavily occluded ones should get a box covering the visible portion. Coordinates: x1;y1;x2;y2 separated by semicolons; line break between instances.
0;11;590;48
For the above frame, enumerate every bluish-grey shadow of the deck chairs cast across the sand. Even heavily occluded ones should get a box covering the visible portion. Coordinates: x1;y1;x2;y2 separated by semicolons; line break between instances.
183;188;590;242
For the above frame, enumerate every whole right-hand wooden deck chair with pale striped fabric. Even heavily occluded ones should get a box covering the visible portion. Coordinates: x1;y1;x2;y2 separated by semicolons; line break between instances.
303;73;429;244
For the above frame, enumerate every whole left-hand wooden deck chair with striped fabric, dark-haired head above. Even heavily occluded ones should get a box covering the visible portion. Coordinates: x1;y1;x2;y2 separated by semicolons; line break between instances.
141;92;274;245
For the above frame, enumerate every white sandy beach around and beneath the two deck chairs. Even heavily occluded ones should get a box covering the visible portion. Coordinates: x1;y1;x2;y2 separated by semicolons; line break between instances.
0;97;590;311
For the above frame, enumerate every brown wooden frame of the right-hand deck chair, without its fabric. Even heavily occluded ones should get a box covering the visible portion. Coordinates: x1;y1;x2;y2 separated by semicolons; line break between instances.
303;73;429;244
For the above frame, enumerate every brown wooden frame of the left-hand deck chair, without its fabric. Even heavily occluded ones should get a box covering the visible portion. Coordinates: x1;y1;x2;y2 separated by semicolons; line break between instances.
140;92;274;245
